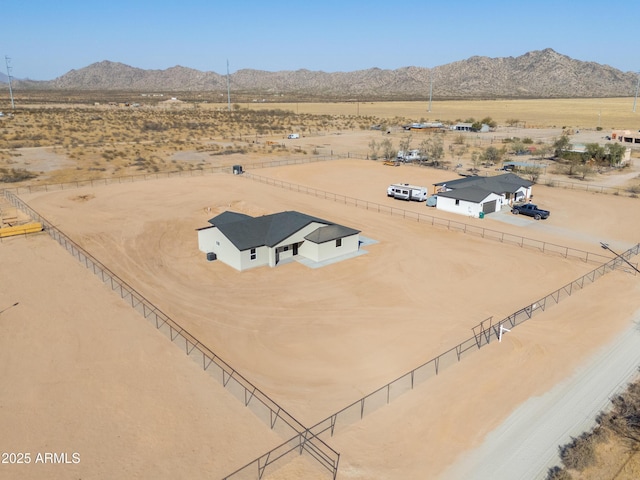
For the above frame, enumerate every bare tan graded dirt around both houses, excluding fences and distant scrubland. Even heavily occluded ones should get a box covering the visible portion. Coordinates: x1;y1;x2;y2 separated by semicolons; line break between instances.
0;152;640;479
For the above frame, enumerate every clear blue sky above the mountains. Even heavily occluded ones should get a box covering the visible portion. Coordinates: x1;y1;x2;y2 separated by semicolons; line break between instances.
5;0;640;80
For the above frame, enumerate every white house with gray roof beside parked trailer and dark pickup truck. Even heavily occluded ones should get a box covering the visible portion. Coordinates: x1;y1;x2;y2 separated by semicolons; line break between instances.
434;173;533;217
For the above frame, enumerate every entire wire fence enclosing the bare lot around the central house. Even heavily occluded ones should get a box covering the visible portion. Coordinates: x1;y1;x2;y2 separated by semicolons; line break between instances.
4;156;640;480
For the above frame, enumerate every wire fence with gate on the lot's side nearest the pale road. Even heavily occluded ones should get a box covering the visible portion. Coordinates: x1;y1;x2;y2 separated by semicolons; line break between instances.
310;244;640;436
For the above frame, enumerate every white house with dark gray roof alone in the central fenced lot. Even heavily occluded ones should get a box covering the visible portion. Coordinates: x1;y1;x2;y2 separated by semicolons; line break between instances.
198;211;360;271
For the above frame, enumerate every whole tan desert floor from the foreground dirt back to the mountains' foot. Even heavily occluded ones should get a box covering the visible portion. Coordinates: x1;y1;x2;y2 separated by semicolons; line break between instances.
0;99;640;480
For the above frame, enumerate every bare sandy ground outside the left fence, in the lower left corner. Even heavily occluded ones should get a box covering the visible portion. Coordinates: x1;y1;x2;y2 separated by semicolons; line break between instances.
0;234;282;479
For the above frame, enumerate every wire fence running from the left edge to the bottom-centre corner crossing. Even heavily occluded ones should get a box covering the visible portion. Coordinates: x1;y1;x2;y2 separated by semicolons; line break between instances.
4;190;340;479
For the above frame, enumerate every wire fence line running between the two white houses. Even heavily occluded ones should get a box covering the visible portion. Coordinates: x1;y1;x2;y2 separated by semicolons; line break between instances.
243;172;609;263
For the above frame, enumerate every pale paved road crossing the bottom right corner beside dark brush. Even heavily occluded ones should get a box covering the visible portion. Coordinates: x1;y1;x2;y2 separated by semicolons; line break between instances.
441;310;640;480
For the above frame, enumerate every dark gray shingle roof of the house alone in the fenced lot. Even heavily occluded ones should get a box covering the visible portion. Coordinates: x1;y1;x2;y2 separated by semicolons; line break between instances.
209;211;351;251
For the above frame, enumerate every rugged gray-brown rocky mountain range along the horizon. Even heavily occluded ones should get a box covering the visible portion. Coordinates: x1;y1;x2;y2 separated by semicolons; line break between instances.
0;48;638;100
